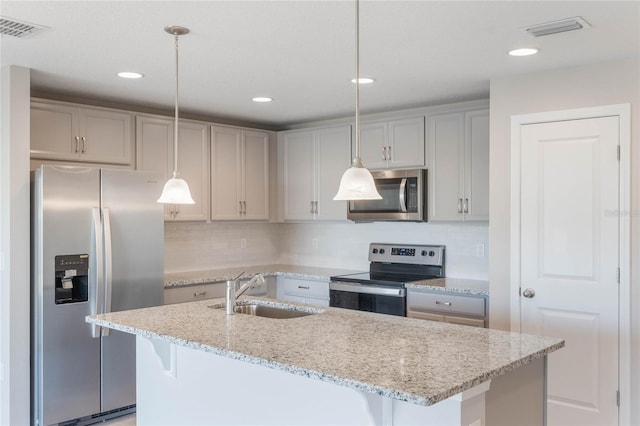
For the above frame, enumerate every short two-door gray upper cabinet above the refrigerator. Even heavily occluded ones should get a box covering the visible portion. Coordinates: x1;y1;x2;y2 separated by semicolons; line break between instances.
31;100;133;165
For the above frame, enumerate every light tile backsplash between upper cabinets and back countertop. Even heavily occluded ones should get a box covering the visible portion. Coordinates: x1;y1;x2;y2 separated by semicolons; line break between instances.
165;222;489;280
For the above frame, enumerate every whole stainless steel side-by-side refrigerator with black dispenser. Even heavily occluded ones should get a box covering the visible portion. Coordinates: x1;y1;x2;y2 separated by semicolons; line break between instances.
31;166;164;425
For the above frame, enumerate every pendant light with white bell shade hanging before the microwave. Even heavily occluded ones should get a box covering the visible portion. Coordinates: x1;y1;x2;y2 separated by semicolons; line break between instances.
333;0;382;200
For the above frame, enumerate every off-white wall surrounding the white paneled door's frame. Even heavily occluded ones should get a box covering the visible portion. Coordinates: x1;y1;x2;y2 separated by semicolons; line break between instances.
489;59;640;424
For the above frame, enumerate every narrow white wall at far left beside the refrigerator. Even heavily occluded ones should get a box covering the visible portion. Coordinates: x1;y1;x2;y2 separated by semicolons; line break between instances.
0;66;31;425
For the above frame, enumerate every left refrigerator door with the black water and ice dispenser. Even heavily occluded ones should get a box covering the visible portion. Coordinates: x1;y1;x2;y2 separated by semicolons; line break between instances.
32;166;100;425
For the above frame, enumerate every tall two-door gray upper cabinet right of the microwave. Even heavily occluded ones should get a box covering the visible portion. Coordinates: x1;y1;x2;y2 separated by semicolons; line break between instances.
427;109;489;222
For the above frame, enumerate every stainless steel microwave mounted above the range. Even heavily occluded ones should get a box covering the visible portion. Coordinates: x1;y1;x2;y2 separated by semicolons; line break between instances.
347;169;427;222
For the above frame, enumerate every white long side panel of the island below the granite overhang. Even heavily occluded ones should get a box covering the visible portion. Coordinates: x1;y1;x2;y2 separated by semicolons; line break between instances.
136;335;485;426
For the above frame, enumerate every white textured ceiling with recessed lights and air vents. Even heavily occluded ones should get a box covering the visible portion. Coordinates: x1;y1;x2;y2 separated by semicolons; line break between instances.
0;0;640;128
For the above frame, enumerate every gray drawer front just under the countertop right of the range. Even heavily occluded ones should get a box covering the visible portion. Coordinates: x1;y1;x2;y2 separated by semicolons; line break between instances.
407;291;485;317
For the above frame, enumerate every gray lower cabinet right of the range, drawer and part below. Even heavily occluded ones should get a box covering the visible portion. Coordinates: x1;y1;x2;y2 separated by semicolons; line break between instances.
407;289;488;327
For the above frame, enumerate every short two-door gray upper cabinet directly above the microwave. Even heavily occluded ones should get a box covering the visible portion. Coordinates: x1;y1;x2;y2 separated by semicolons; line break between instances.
360;117;425;169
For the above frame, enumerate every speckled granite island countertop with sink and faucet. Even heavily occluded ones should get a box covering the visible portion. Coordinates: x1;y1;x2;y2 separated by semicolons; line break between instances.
87;296;564;405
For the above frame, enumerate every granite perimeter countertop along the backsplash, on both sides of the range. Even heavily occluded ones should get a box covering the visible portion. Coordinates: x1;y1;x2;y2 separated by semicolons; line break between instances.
164;264;489;296
